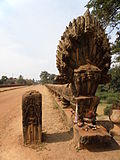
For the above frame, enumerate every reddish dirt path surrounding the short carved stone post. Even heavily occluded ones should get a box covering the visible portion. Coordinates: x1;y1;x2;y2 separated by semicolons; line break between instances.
0;85;120;160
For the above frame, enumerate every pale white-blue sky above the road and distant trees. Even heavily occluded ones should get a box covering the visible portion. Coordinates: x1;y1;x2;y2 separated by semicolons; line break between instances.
0;0;116;79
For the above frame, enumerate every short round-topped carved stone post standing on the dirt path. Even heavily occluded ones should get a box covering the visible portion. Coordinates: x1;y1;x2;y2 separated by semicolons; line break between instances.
22;90;42;144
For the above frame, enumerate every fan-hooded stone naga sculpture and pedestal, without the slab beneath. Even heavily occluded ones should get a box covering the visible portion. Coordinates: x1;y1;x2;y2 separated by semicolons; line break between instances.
56;10;111;123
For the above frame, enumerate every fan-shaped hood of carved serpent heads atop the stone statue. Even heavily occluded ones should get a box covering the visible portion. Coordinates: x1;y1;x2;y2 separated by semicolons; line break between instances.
56;10;111;84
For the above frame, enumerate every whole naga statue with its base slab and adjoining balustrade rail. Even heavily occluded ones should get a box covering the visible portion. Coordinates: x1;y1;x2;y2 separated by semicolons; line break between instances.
48;10;111;147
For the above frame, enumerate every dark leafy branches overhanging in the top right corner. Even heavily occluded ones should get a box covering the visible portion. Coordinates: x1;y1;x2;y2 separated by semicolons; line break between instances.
86;0;120;29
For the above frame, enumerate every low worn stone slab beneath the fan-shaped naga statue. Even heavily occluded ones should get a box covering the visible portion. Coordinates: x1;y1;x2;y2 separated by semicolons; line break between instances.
73;124;112;149
